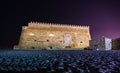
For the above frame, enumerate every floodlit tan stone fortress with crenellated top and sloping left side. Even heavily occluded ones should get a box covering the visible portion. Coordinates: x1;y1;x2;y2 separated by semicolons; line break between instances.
14;22;91;50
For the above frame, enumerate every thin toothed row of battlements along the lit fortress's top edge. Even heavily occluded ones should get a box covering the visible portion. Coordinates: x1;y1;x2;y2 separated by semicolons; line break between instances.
28;22;89;29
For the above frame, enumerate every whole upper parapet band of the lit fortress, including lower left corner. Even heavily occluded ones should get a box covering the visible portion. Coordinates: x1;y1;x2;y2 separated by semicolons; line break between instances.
22;22;90;34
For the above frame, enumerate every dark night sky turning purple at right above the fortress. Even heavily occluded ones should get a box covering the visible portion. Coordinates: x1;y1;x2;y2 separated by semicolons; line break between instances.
0;0;120;47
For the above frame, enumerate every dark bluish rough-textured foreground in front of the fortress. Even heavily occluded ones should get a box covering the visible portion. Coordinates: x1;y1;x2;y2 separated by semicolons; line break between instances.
0;50;120;73
